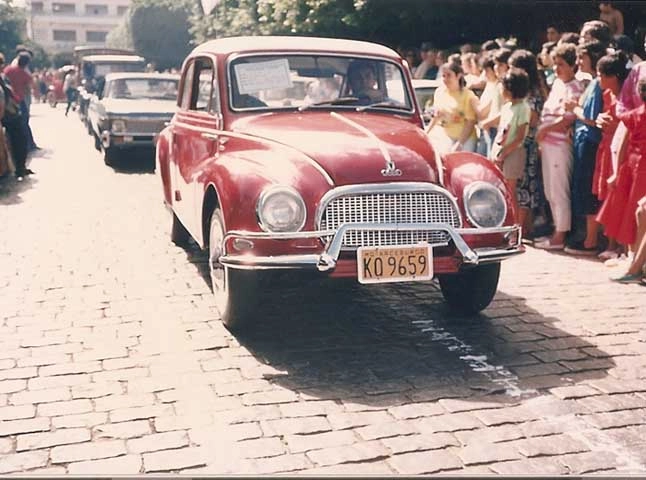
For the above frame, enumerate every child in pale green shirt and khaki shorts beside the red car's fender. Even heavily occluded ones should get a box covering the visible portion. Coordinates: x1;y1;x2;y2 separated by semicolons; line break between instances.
490;68;531;223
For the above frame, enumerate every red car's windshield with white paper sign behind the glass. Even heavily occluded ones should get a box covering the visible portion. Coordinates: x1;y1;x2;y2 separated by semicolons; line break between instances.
229;55;413;112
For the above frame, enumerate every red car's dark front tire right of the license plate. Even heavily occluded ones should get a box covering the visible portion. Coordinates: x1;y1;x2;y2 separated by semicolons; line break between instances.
438;263;500;315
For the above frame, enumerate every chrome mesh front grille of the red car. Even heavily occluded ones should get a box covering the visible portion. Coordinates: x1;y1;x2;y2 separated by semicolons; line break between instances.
320;191;460;248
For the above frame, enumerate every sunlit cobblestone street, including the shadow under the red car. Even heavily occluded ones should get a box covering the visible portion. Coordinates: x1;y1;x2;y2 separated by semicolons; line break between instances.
0;104;646;475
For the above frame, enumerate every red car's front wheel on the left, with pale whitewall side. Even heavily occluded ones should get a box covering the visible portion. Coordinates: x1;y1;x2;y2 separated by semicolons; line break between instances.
208;208;261;332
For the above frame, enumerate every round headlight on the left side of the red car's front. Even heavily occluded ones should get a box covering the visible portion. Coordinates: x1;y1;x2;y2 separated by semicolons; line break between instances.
257;186;306;232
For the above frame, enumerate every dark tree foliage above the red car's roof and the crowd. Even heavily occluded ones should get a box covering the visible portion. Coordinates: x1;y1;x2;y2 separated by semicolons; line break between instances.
191;0;646;56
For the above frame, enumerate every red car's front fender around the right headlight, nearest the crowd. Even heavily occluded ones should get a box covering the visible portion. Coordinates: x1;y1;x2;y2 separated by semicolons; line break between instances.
442;152;514;225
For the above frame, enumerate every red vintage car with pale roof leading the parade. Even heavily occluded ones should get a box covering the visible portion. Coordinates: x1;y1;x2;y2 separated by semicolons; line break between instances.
156;36;523;330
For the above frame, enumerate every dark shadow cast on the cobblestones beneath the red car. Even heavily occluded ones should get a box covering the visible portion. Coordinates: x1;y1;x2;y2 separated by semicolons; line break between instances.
224;279;614;406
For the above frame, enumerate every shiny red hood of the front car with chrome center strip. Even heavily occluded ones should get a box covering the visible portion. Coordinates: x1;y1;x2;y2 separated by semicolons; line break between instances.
232;111;438;185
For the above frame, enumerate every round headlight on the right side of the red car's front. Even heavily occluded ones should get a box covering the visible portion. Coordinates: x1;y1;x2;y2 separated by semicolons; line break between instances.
464;182;507;228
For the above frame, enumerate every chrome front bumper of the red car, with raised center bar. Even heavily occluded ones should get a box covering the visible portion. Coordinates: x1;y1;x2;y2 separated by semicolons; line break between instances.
220;223;523;272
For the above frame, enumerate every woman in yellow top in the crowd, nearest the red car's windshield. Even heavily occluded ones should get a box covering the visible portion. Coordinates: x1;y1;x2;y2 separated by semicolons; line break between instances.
426;62;478;154
